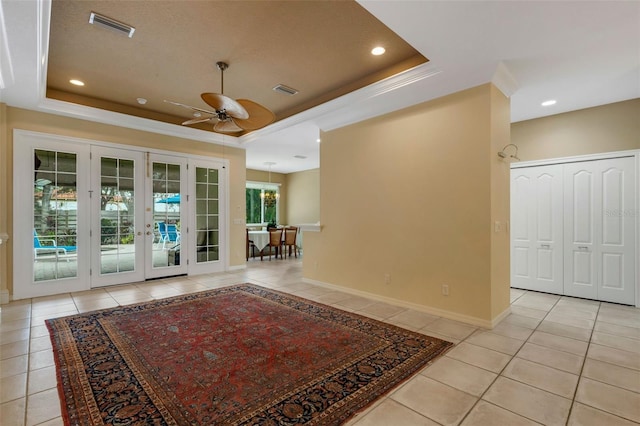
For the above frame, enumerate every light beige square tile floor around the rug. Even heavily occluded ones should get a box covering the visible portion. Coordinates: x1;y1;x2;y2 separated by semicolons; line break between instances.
0;260;640;426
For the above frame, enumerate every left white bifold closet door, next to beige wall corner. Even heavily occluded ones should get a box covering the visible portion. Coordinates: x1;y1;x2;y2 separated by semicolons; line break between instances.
511;165;563;293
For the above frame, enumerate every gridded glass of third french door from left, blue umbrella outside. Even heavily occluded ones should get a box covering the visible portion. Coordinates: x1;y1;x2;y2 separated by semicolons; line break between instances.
152;162;181;268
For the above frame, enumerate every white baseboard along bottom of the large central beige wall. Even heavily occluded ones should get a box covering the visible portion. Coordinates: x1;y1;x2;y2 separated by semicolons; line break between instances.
302;278;511;329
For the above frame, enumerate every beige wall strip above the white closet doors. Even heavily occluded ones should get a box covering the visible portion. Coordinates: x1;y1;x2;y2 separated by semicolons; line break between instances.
511;99;640;161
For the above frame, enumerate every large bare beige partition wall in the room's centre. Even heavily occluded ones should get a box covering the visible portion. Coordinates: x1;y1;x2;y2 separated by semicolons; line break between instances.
303;85;509;324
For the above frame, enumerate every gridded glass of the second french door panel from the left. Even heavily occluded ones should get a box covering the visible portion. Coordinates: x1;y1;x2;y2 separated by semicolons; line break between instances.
100;157;135;274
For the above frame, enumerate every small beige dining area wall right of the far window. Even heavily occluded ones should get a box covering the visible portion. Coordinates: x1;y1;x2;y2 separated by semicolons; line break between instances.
287;169;320;225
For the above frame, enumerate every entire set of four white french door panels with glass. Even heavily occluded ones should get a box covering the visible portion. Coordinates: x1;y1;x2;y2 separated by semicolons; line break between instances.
12;130;228;299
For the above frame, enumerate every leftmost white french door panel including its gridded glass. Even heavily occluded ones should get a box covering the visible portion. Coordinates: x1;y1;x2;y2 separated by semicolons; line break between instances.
13;130;91;299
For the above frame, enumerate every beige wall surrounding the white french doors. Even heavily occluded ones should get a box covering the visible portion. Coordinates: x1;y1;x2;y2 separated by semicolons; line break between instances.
0;104;246;300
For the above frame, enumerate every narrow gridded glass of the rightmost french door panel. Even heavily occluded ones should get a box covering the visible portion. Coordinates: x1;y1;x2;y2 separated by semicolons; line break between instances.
196;167;220;263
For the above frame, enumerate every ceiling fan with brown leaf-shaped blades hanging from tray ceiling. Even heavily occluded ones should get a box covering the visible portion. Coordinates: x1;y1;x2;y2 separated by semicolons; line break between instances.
165;62;276;133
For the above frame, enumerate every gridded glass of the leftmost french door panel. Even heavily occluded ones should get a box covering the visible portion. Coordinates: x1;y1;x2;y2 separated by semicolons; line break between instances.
33;150;78;281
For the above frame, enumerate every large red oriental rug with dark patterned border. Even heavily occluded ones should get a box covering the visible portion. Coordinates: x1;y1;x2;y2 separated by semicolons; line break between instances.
46;284;452;425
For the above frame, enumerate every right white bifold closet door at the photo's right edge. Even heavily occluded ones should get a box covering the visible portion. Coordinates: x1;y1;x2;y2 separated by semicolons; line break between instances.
564;157;637;304
